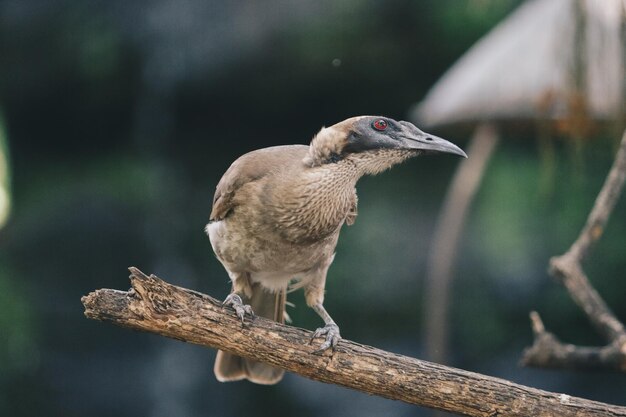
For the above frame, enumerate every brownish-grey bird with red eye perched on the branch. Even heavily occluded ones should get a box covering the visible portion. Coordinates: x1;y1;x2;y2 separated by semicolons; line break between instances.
205;116;467;385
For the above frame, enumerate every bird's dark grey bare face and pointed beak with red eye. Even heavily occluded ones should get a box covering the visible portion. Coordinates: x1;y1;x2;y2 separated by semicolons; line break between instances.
343;116;467;158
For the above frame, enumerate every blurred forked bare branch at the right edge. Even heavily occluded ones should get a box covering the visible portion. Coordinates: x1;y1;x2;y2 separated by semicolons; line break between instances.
522;131;626;372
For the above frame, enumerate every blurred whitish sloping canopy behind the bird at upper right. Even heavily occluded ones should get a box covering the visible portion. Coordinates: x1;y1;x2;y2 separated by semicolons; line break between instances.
412;0;626;127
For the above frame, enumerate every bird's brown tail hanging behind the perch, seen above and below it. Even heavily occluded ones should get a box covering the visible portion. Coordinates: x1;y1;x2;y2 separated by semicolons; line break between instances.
213;284;286;385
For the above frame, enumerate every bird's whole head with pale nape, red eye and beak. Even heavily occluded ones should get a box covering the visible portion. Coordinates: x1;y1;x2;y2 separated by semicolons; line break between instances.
306;116;467;174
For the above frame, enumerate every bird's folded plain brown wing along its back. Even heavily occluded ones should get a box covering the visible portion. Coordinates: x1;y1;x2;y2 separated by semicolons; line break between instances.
210;145;309;221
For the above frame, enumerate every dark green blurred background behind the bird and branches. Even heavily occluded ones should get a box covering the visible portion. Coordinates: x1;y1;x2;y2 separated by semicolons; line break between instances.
0;0;626;417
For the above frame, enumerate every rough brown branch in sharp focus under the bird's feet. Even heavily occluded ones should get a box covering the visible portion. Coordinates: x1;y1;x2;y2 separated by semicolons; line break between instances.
82;268;626;417
